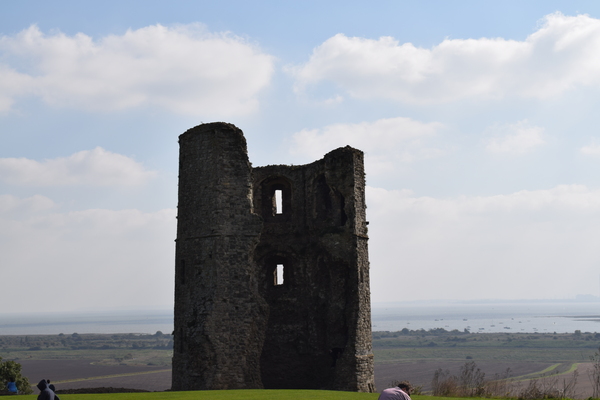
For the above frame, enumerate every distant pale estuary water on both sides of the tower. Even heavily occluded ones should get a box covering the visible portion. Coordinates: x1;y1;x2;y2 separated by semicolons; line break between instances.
0;301;600;335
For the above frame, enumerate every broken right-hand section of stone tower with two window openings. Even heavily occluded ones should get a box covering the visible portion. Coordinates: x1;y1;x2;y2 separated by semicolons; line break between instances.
254;147;374;391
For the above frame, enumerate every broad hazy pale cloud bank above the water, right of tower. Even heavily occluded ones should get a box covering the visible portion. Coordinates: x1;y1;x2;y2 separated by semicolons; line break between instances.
367;185;600;301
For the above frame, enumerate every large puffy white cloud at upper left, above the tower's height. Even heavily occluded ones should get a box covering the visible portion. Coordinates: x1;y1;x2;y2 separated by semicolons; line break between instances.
0;25;274;116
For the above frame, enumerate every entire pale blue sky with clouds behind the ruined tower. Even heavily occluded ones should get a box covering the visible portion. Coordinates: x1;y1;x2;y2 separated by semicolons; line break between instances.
0;0;600;313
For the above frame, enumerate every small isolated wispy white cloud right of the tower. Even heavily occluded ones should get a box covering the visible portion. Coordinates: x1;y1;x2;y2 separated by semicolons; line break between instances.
486;120;546;154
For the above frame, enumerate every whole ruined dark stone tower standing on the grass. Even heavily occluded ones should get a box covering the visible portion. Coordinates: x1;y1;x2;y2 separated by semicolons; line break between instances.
173;123;375;392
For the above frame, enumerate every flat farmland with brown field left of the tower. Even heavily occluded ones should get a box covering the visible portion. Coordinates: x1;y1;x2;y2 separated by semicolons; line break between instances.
0;332;173;391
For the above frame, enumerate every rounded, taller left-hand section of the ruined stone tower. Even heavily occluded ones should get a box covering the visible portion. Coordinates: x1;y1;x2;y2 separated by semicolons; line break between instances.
172;123;267;390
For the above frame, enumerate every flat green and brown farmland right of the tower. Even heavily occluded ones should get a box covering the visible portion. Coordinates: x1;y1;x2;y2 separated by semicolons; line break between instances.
373;329;600;398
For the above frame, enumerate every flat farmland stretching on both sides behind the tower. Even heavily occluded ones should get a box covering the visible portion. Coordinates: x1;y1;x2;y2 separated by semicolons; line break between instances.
0;329;600;397
